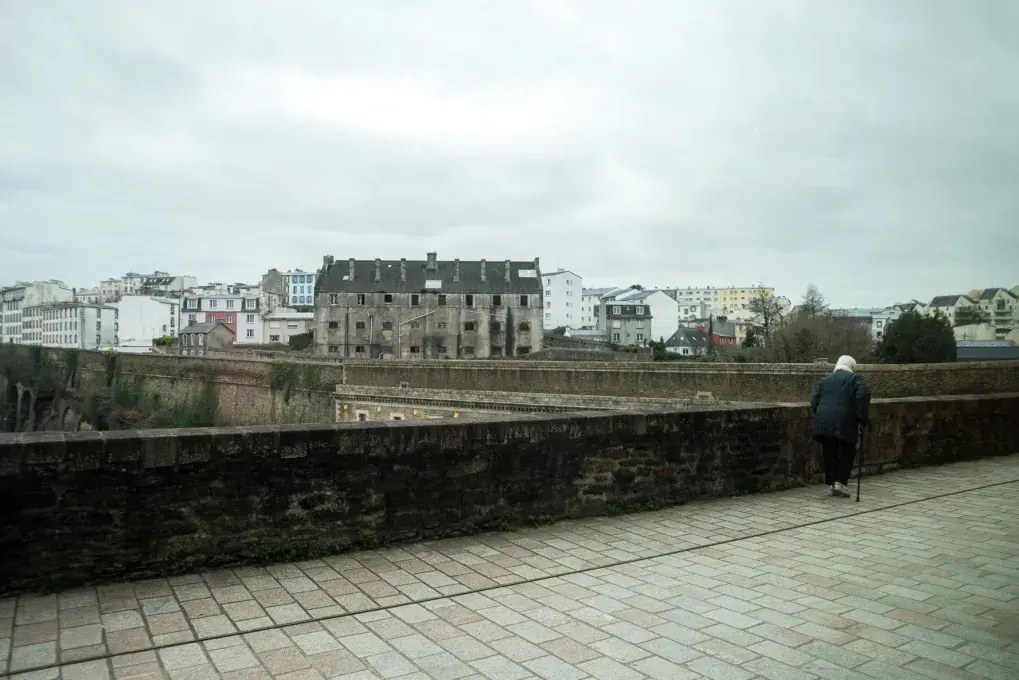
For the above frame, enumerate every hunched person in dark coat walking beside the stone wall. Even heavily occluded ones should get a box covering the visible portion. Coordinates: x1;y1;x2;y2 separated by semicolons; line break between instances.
810;356;870;496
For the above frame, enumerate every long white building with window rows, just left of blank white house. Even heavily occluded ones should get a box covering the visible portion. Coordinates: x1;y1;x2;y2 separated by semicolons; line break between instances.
22;302;118;350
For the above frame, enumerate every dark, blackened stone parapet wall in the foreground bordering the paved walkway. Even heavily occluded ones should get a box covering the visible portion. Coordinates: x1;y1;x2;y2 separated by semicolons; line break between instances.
0;395;1019;591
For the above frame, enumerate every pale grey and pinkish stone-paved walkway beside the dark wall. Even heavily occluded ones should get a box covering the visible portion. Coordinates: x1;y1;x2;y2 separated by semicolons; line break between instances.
0;456;1019;680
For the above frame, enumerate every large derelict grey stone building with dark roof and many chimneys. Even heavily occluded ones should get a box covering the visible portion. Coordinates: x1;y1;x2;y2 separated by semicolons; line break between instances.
315;253;543;359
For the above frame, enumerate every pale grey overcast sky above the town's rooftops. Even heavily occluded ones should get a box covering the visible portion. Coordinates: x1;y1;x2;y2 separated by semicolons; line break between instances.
0;0;1019;306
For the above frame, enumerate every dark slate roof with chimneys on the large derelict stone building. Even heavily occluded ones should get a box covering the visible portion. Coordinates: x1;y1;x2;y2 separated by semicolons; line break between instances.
315;258;541;295
